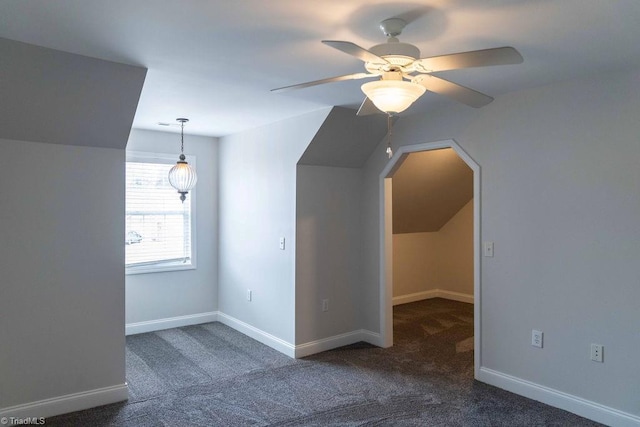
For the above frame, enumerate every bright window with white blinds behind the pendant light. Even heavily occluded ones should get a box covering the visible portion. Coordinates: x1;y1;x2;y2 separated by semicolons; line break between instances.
124;152;195;274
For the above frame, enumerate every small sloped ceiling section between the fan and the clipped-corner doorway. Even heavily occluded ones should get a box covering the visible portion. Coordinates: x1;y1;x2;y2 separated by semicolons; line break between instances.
298;107;387;168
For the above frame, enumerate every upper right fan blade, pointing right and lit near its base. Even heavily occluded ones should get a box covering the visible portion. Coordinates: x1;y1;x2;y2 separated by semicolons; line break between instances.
413;47;524;73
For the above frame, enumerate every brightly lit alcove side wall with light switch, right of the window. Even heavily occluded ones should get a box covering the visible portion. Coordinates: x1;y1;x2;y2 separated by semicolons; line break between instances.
218;110;329;344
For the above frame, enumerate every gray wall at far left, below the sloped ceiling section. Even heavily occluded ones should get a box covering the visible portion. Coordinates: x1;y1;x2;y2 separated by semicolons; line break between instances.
0;140;125;408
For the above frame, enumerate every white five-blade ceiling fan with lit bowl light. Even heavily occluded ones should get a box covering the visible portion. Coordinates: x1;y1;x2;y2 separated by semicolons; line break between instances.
272;18;523;116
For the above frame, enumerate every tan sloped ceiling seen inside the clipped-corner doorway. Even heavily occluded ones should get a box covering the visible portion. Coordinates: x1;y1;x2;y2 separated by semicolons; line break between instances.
391;148;473;233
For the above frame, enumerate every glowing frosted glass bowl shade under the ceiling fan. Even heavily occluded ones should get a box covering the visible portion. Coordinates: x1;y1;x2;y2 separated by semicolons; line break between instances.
361;80;426;113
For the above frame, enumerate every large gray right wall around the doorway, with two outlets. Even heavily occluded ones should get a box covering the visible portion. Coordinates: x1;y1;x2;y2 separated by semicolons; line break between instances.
361;71;640;416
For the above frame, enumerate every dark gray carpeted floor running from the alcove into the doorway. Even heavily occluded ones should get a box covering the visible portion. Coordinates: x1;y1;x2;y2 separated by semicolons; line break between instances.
47;298;599;427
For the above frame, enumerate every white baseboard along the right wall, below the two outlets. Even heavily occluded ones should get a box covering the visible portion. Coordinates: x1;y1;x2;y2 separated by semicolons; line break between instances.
476;367;640;427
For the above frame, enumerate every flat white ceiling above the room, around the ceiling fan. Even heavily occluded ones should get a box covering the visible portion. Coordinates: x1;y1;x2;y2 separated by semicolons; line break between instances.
0;0;640;136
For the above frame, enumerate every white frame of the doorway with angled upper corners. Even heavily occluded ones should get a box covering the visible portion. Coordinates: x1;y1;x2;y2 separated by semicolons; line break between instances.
379;139;482;376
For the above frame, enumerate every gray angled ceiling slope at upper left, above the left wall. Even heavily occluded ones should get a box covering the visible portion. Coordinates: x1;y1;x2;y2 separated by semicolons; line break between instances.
0;38;147;148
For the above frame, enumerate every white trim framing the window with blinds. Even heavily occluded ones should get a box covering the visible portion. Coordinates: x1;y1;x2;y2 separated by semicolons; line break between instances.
124;151;198;276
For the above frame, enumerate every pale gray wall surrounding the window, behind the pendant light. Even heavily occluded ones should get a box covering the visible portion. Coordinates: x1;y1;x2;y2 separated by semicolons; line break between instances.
125;129;218;324
